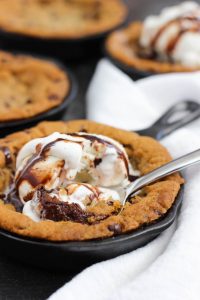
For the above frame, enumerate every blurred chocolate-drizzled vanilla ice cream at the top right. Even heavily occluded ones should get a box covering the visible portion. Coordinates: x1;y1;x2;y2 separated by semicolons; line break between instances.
140;1;200;67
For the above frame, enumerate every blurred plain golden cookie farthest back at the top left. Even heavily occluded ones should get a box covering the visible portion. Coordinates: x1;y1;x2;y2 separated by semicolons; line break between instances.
0;0;127;39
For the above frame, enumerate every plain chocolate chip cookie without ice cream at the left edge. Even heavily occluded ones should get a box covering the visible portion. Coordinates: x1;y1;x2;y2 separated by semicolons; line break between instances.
0;51;70;122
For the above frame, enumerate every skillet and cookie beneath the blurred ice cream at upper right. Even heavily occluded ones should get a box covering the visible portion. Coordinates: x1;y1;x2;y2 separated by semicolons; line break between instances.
104;22;199;80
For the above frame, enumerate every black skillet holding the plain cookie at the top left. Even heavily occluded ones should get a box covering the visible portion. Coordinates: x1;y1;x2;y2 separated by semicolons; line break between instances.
0;17;127;60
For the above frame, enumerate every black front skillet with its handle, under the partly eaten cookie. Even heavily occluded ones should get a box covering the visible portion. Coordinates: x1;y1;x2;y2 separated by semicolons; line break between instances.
0;101;200;270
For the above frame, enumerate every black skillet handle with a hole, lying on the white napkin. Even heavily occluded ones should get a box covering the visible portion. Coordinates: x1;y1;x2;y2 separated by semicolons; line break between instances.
137;100;200;140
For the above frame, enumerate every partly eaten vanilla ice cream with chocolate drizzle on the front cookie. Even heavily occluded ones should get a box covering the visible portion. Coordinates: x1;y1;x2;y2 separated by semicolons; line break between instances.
15;133;138;211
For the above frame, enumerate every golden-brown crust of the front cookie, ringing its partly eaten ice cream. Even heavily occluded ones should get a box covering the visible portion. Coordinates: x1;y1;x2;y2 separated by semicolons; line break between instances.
0;120;183;241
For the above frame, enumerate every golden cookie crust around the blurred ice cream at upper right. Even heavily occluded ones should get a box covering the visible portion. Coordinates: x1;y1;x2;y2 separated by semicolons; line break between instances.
105;22;199;73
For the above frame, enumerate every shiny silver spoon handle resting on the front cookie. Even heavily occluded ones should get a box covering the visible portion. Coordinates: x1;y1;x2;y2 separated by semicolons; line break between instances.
123;149;200;204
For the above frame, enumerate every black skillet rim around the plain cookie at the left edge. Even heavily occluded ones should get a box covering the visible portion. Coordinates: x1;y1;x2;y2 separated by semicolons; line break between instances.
0;51;78;137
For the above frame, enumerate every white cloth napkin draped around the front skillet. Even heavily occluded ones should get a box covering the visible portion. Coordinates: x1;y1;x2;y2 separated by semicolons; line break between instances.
50;60;200;300
